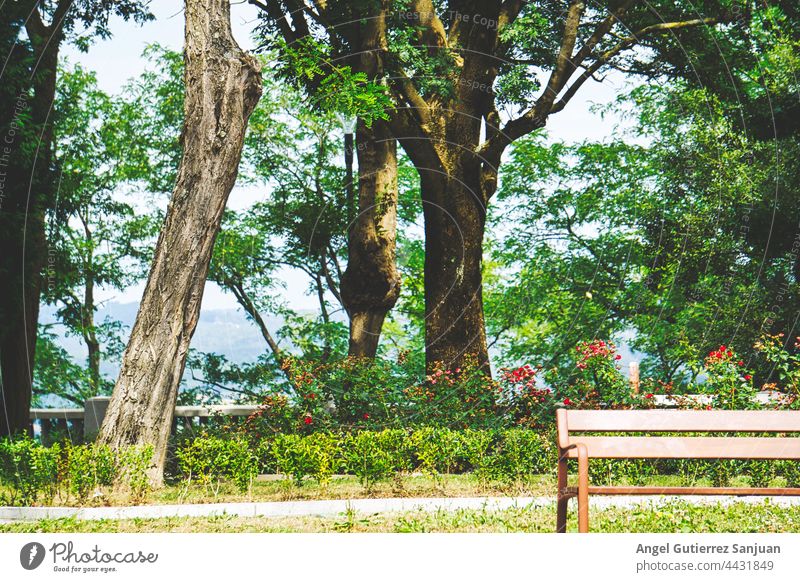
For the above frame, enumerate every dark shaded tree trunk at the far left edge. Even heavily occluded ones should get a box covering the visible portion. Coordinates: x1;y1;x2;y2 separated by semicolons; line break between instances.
0;24;57;436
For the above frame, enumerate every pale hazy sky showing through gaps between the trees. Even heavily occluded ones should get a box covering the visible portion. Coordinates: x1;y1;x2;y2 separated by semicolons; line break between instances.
63;0;623;309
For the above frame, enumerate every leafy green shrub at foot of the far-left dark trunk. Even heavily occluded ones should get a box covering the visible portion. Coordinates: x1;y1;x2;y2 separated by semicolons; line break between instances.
0;436;59;505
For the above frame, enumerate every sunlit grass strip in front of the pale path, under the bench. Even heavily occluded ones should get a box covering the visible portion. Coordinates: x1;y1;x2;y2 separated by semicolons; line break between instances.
0;501;800;533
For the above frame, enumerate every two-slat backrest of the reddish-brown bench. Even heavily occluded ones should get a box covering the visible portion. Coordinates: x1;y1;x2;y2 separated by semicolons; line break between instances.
556;409;800;459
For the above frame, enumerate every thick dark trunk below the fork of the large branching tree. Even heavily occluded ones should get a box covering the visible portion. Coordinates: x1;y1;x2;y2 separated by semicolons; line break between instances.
421;164;490;373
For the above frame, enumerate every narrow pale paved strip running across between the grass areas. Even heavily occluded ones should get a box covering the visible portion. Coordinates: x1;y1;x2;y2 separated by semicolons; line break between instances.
0;495;800;523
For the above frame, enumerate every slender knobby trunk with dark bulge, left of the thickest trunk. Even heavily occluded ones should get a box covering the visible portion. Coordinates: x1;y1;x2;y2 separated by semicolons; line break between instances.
341;121;400;358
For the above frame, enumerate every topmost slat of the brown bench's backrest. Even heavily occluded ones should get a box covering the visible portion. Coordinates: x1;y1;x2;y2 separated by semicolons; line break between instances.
559;410;800;432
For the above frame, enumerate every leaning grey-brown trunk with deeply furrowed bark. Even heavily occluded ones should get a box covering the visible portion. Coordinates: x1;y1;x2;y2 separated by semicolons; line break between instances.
99;0;261;485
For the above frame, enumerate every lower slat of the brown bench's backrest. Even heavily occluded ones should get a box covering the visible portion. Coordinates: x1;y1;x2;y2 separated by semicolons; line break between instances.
567;435;800;459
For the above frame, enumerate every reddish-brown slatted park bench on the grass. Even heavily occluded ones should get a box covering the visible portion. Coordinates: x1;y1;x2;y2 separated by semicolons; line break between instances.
556;409;800;533
